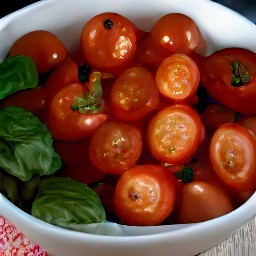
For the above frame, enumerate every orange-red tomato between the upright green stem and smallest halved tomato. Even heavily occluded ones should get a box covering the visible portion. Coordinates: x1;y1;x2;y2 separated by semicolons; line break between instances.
110;67;159;122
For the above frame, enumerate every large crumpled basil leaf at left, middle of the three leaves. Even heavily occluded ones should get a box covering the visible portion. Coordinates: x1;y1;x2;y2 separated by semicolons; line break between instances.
0;107;61;181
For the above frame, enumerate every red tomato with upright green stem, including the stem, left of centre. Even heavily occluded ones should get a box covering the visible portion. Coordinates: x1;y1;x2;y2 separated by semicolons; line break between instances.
47;73;108;142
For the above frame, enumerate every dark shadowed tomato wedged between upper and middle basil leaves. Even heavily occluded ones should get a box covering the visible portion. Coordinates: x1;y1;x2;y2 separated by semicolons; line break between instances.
0;86;46;116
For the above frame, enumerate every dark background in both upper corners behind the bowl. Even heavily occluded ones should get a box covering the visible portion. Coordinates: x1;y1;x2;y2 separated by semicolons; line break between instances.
0;0;256;23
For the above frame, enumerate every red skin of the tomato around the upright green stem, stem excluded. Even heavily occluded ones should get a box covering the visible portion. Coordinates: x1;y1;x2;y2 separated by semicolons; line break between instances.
47;83;108;142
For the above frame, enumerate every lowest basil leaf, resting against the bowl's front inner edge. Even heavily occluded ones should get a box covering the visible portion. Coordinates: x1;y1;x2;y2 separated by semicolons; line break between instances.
31;177;106;229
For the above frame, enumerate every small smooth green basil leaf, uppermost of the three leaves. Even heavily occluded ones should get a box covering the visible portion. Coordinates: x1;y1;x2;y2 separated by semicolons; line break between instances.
0;55;39;99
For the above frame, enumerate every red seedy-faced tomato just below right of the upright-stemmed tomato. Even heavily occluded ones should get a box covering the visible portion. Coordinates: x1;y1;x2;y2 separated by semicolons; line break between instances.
89;120;142;175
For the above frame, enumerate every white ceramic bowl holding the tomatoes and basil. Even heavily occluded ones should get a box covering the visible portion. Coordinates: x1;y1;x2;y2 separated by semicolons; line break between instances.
0;0;256;256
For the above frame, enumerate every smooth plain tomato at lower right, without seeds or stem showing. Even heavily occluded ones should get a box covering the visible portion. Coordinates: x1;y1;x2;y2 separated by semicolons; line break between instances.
177;181;234;223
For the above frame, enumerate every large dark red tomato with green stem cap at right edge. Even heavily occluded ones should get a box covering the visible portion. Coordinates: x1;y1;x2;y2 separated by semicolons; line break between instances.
199;48;256;114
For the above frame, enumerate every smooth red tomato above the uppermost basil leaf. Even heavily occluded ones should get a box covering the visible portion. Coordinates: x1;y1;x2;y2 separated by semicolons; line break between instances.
9;30;67;74
